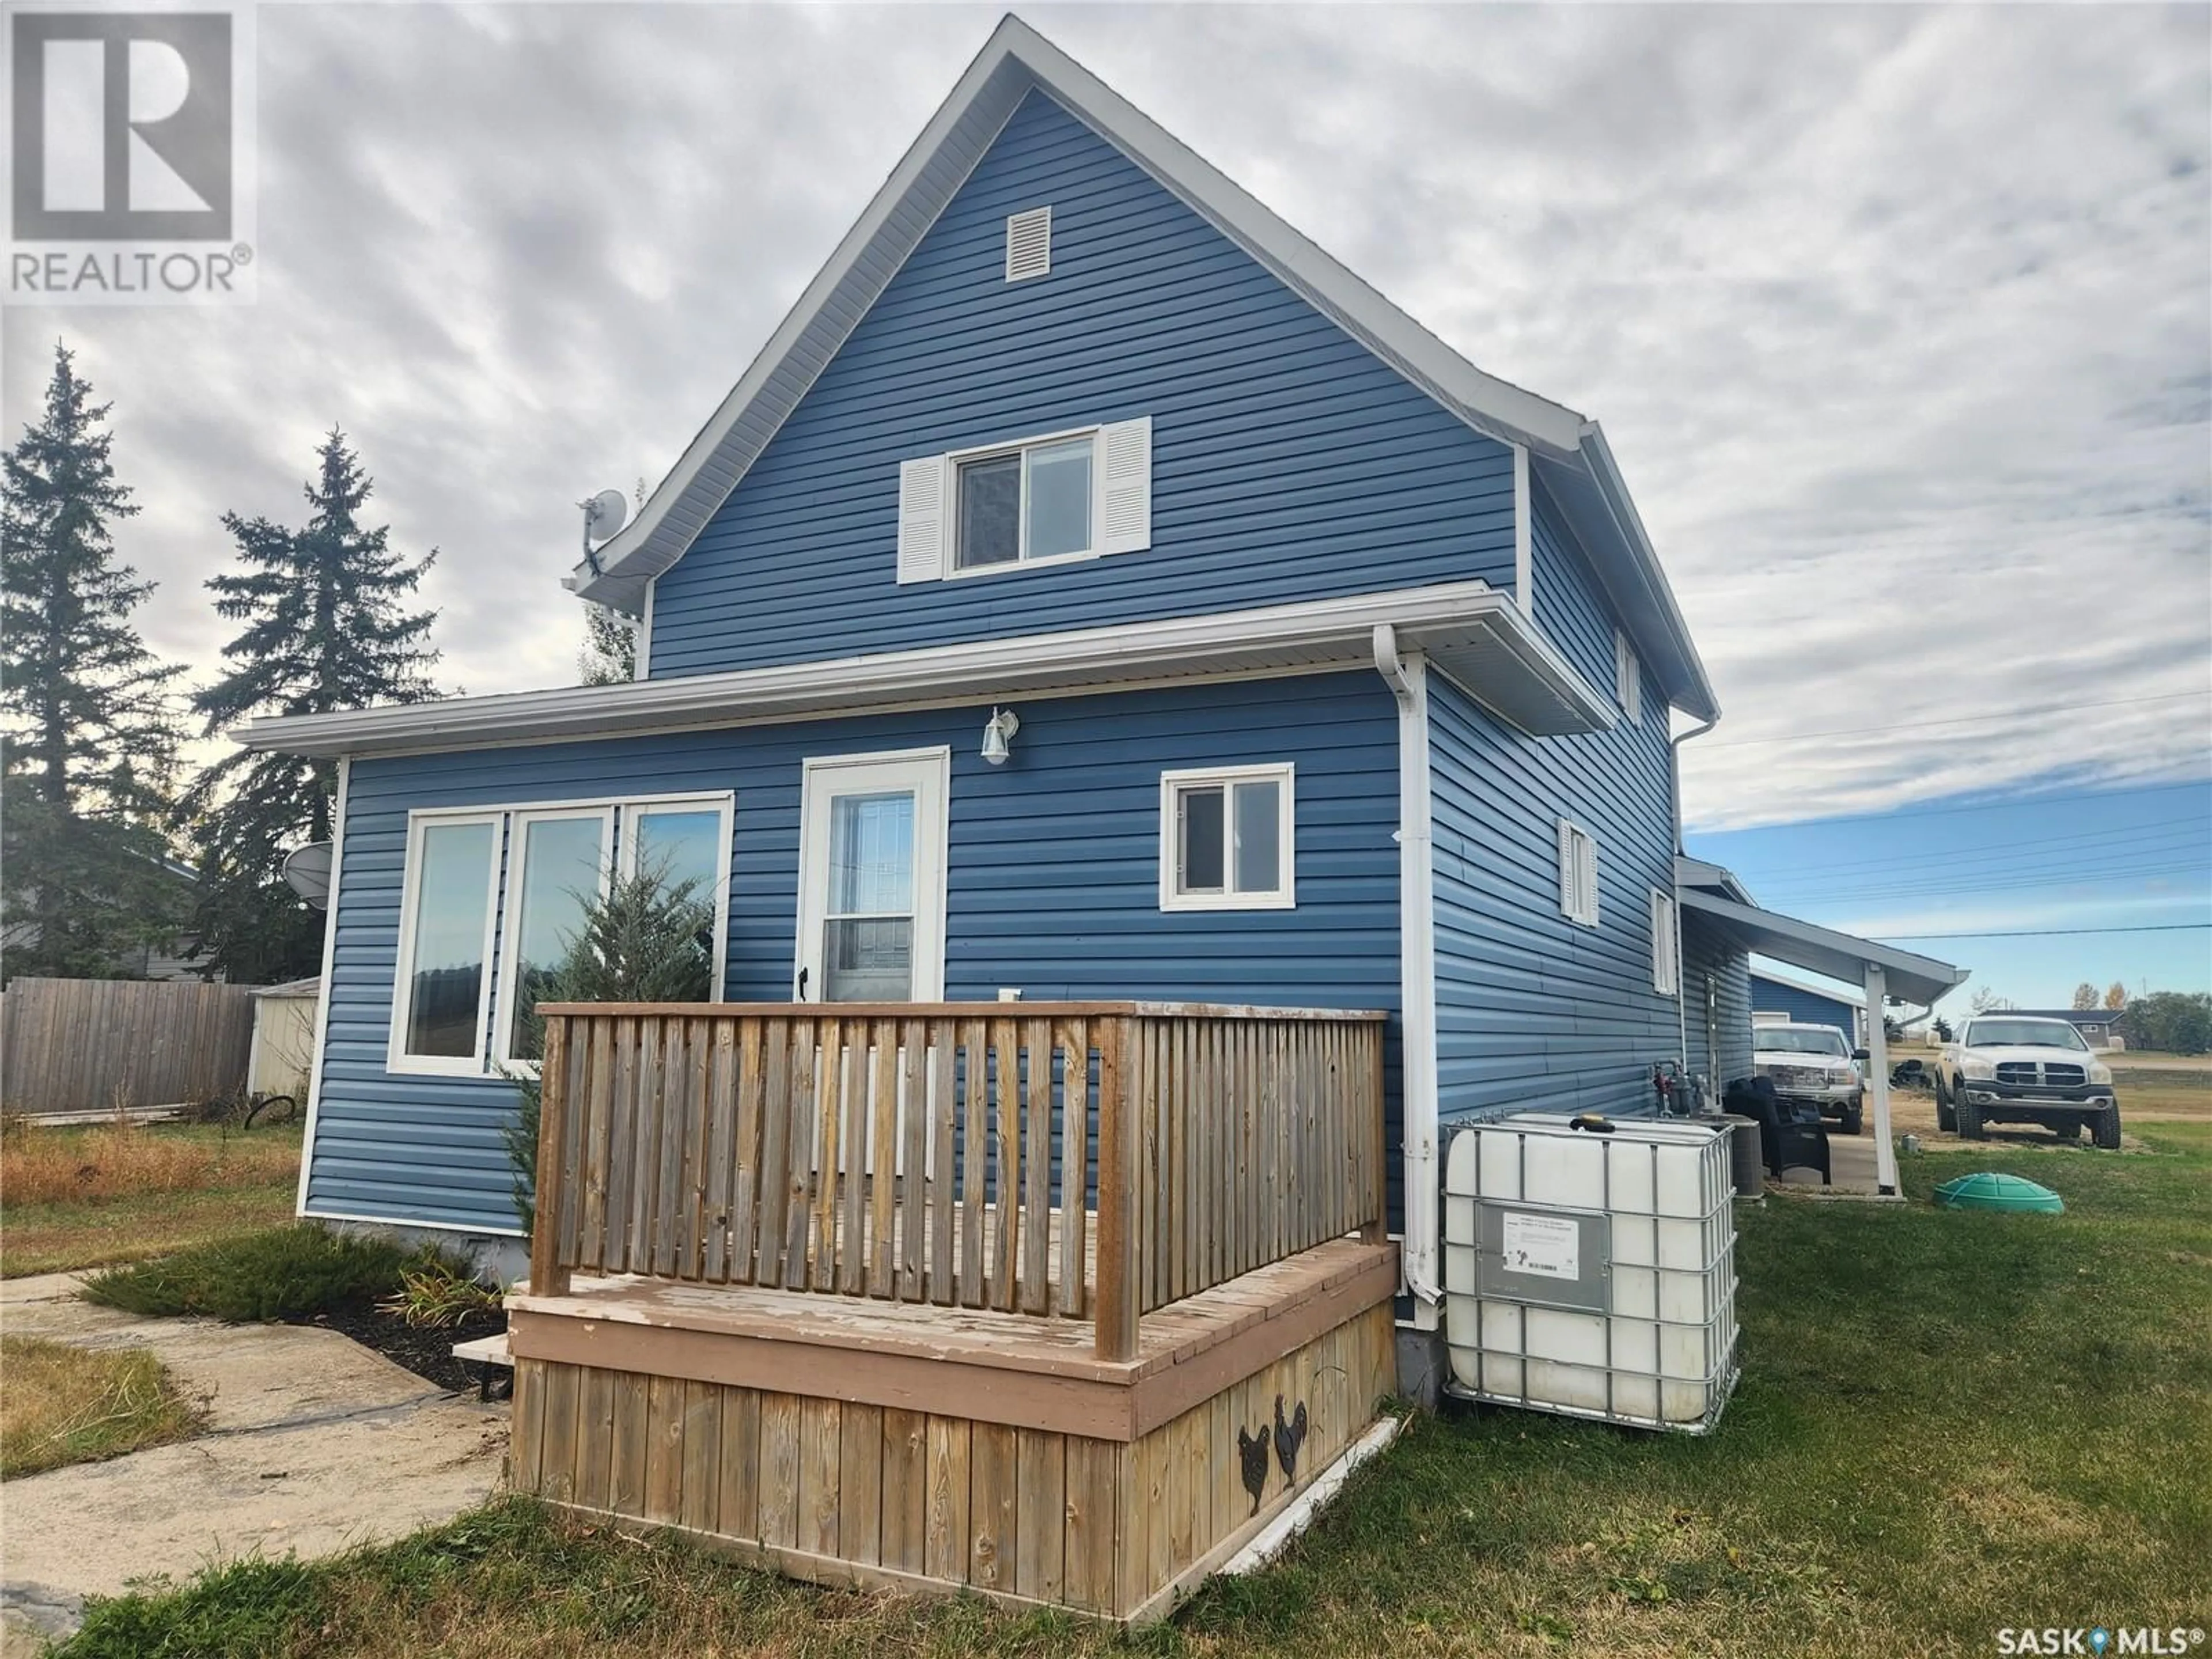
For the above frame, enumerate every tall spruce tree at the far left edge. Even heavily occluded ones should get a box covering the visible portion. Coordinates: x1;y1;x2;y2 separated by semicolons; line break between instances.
0;345;184;978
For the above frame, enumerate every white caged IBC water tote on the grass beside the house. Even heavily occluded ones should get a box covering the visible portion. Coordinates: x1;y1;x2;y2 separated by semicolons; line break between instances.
1445;1113;1736;1433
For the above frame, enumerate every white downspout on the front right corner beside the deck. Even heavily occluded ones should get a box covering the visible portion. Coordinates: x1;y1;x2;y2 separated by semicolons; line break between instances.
1374;622;1442;1332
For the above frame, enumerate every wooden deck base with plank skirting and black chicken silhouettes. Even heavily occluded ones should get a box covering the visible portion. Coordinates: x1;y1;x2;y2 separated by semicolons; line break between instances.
511;1248;1396;1622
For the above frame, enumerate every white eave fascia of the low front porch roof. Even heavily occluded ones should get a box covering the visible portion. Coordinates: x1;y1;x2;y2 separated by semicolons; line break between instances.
232;582;1611;754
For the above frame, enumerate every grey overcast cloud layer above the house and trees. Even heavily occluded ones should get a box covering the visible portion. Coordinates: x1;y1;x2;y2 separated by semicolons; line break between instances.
0;5;2212;986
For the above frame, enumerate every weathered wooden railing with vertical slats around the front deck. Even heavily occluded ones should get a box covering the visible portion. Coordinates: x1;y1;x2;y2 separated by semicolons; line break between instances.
531;1002;1382;1358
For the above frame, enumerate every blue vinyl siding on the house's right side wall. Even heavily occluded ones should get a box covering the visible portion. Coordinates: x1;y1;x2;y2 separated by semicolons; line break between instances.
1429;495;1681;1122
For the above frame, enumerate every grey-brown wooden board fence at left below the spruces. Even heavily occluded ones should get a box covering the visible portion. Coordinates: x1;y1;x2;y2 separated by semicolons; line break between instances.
0;978;255;1115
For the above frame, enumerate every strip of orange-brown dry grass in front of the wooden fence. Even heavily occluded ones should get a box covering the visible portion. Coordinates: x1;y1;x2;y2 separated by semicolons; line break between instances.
0;1117;298;1206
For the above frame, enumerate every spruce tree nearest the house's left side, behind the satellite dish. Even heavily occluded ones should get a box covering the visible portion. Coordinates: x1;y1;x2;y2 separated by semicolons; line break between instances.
186;427;438;982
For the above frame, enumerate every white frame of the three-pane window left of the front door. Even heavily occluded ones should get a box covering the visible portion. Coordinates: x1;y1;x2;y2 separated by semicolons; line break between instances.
385;790;737;1077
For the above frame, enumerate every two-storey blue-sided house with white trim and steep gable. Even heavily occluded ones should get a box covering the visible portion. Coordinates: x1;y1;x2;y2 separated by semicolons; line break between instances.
241;18;1955;1478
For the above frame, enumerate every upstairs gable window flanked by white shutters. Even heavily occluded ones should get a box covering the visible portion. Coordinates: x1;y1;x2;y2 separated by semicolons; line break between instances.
898;416;1153;584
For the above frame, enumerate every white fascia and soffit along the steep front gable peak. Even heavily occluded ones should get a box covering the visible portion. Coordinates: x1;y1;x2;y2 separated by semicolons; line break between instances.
569;16;1586;615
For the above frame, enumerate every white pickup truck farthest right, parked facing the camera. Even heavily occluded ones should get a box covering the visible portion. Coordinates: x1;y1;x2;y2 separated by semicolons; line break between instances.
1936;1013;2119;1148
